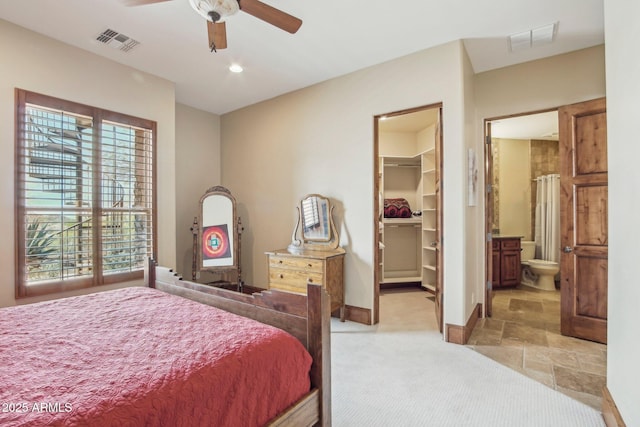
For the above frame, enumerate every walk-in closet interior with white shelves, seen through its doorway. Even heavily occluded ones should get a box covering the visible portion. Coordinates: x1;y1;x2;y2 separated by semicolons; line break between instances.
378;110;439;293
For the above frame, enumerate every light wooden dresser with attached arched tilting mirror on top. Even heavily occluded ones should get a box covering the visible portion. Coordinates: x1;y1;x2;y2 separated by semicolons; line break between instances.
266;194;345;321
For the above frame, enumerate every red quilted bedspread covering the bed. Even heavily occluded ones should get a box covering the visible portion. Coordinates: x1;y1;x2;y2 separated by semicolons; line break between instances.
0;288;311;426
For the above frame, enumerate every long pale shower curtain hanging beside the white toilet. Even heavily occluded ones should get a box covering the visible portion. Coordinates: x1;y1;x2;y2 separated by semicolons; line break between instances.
535;174;560;262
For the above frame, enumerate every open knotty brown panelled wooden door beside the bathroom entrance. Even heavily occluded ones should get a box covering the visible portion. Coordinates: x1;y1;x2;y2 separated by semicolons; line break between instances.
558;98;609;343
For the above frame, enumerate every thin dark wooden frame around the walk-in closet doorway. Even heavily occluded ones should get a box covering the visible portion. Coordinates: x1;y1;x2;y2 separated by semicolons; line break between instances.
371;102;444;326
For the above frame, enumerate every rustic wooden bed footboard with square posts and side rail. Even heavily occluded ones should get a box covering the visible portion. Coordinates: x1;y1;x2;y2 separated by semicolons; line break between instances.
144;259;331;427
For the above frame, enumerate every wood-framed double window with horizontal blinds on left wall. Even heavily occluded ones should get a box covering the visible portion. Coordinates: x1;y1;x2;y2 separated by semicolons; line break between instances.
15;89;157;298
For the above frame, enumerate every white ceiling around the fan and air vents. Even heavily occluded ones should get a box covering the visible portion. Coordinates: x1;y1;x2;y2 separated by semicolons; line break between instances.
0;0;604;114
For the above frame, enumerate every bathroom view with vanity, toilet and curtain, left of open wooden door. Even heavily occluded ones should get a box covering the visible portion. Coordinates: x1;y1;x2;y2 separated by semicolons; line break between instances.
486;109;560;316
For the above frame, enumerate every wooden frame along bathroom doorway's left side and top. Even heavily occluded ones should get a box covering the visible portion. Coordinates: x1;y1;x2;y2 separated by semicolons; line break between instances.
483;107;560;317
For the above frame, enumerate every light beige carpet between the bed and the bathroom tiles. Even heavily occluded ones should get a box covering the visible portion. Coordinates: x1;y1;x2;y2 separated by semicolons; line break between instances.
331;291;604;427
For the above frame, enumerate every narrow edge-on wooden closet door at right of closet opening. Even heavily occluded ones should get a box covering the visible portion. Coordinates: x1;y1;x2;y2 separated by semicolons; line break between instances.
435;108;444;333
